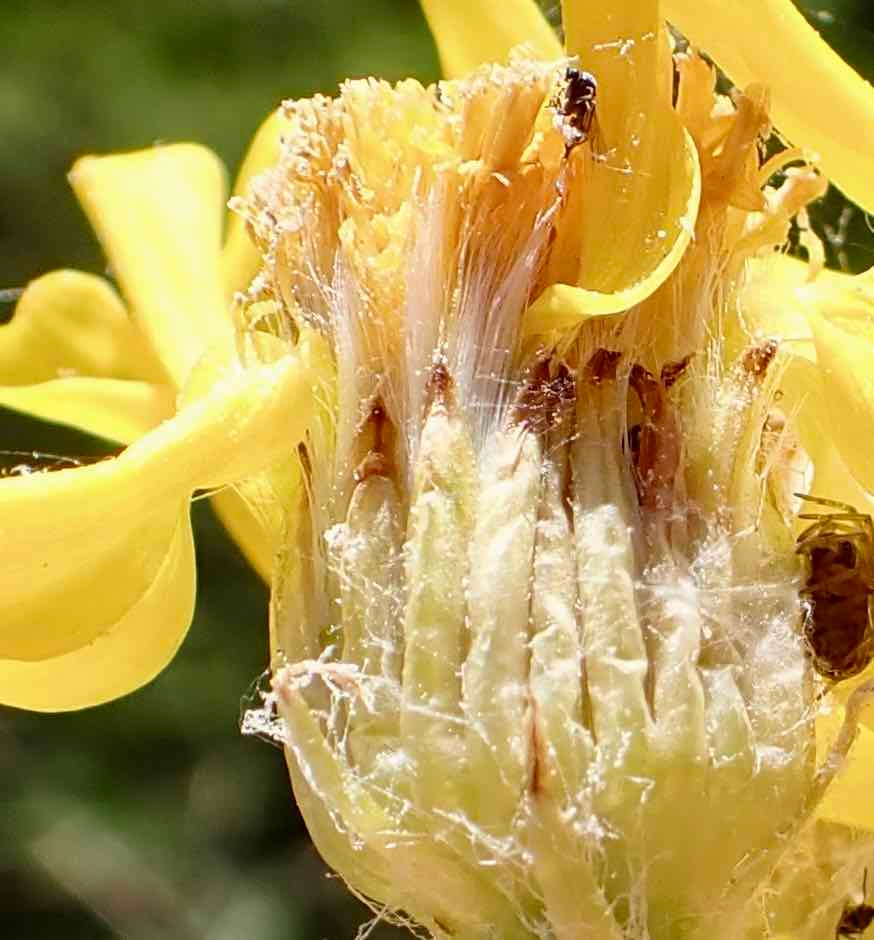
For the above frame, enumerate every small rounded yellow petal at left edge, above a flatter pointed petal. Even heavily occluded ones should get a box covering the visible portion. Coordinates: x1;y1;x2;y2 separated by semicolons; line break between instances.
0;271;166;385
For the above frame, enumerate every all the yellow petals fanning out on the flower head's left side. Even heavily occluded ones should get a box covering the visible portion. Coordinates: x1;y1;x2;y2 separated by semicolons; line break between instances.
0;115;332;710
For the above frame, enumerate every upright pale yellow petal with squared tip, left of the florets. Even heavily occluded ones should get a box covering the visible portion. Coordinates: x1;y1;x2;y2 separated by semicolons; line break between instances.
70;144;233;386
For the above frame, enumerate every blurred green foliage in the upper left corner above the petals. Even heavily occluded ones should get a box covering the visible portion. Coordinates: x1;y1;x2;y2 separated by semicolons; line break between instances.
0;0;437;287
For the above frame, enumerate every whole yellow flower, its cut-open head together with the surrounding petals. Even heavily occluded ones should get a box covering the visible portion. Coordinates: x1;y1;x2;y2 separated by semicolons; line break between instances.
0;0;874;940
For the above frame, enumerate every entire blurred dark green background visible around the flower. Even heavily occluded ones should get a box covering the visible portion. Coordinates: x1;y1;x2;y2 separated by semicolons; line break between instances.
0;0;874;940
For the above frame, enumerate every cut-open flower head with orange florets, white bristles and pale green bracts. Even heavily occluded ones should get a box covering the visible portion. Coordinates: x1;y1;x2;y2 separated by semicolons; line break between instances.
227;53;872;940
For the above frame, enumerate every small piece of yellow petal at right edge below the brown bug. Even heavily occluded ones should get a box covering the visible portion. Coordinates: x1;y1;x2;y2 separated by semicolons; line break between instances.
816;706;874;831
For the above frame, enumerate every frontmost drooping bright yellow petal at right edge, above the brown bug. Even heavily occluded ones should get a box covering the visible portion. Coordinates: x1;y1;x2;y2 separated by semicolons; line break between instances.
810;278;874;493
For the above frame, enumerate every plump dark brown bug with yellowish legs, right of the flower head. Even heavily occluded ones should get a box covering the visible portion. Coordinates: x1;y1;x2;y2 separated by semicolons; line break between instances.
796;494;874;682
